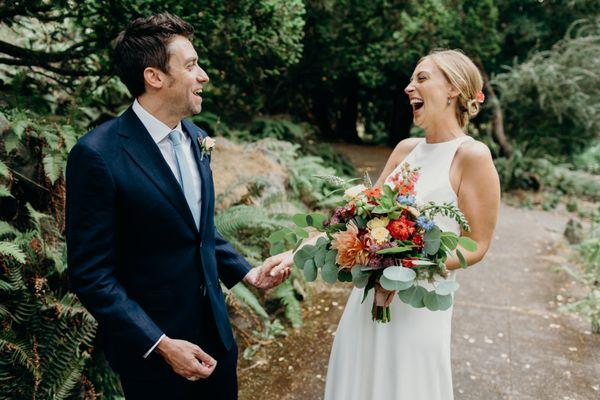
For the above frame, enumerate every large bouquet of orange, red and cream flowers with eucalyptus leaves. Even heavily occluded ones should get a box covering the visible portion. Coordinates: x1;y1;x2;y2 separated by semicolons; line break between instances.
269;163;477;322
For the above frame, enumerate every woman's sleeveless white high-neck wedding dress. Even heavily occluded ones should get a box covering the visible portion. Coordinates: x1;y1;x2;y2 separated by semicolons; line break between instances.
325;136;473;400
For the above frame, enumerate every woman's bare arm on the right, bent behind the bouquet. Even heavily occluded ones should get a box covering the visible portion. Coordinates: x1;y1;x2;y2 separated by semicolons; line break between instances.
446;142;500;270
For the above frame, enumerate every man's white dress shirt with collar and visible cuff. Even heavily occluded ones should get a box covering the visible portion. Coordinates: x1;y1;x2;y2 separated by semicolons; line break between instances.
132;99;202;358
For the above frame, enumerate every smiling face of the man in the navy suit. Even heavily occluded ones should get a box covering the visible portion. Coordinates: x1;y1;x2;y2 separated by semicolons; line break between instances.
163;36;208;118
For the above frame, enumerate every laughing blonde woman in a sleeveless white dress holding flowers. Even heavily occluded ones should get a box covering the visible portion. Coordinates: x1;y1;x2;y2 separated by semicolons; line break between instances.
264;50;500;400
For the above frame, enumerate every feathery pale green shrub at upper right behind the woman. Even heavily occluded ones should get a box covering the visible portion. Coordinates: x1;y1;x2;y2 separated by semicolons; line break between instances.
493;19;600;157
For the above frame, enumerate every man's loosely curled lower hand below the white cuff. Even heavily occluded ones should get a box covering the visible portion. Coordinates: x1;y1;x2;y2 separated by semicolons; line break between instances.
156;337;217;380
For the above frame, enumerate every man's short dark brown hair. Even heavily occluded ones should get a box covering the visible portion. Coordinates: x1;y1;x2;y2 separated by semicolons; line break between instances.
114;13;194;97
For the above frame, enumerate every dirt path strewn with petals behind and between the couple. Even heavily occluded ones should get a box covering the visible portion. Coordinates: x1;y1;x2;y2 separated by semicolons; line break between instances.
240;145;600;400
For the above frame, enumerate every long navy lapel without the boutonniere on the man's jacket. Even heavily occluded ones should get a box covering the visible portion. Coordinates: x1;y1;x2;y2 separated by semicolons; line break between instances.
119;107;198;232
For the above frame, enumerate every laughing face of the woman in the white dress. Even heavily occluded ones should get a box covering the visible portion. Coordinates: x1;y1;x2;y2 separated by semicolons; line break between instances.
404;58;453;129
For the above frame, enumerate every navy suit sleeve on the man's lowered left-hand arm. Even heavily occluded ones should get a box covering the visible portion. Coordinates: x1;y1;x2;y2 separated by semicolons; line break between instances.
66;143;163;357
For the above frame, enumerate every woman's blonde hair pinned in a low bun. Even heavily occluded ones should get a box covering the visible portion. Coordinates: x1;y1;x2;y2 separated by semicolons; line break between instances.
417;50;483;128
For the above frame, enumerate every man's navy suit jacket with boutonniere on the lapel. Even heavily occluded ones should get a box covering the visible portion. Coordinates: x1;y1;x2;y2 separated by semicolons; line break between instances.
66;107;251;377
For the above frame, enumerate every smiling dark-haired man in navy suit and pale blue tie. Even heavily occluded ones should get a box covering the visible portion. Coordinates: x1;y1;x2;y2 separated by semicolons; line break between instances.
67;14;289;400
